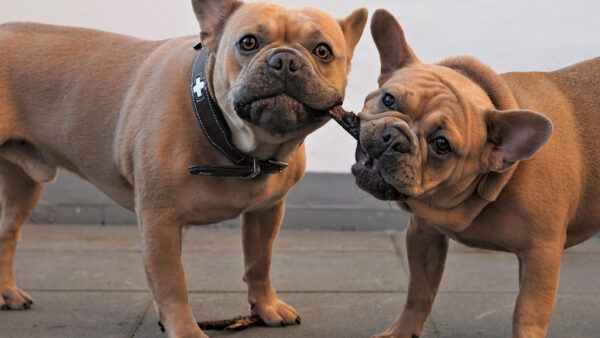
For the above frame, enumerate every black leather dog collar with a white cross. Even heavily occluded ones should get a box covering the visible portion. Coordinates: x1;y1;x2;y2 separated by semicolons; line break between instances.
189;43;288;179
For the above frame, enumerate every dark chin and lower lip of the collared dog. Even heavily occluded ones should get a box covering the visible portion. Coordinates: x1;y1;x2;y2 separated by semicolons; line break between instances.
234;94;328;134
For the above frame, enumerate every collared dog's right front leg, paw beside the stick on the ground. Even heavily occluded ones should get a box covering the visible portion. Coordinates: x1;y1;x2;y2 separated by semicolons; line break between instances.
242;202;300;326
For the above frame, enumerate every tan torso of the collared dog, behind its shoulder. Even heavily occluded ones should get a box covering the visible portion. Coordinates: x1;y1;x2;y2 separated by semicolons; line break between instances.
0;23;179;205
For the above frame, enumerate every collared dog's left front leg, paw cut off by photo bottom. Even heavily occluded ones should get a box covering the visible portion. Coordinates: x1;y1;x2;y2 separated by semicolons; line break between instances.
138;210;207;337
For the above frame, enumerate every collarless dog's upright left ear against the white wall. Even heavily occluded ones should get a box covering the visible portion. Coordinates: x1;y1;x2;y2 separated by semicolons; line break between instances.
371;9;420;87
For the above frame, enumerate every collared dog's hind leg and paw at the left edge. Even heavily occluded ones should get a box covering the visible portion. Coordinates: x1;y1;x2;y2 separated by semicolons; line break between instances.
0;159;43;310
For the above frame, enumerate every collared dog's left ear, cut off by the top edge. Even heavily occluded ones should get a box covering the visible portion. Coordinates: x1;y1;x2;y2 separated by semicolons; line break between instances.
192;0;242;50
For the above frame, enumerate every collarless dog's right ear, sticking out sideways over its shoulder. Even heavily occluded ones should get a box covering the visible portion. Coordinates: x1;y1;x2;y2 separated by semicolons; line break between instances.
482;109;552;173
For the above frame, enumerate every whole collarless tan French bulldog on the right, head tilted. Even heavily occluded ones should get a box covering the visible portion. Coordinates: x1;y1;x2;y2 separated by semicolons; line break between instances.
352;10;600;337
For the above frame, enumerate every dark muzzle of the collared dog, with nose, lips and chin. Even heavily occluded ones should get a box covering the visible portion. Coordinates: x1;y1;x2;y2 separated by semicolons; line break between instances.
232;48;342;133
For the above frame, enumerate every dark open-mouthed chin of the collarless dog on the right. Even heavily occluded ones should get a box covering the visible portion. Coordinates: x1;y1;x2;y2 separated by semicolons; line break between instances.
352;144;407;201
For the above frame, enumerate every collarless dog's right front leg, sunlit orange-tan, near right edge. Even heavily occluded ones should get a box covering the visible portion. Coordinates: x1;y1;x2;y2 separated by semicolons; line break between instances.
513;243;563;337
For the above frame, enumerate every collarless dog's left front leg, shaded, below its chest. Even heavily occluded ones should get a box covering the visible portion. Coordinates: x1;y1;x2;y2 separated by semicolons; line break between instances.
374;215;448;338
